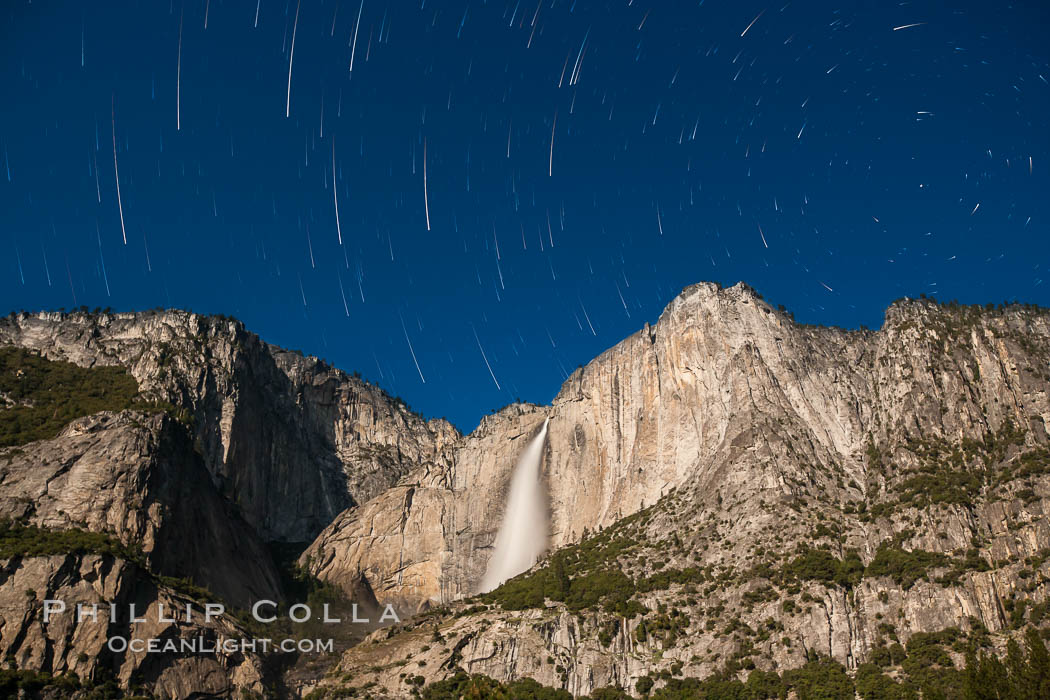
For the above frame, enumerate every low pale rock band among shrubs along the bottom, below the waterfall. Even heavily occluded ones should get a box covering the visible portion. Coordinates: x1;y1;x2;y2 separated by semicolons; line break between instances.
322;558;1046;698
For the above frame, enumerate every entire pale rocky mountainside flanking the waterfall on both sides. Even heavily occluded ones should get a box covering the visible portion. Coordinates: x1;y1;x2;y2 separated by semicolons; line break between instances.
309;284;1050;693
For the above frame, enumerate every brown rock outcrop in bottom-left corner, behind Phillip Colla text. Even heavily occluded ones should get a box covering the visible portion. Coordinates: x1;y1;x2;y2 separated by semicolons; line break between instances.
0;554;267;700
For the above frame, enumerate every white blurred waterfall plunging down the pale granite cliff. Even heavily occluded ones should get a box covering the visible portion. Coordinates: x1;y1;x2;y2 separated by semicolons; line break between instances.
480;419;550;593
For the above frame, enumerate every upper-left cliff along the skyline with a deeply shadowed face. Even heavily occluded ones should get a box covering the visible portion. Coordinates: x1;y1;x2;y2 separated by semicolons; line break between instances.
0;311;458;542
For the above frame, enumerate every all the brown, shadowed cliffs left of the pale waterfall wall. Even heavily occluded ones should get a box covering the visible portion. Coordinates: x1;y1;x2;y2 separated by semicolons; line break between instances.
0;311;458;698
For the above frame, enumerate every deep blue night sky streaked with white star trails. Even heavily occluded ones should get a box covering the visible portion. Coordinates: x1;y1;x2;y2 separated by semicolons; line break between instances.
0;0;1050;430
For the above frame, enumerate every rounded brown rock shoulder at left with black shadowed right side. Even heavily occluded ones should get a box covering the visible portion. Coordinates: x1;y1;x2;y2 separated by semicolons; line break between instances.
0;411;282;608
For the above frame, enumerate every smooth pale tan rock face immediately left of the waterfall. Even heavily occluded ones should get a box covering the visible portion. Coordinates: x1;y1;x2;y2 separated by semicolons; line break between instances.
299;405;546;612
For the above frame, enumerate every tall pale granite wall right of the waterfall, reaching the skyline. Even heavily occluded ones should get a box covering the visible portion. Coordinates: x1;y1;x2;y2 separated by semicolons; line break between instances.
549;284;1050;546
